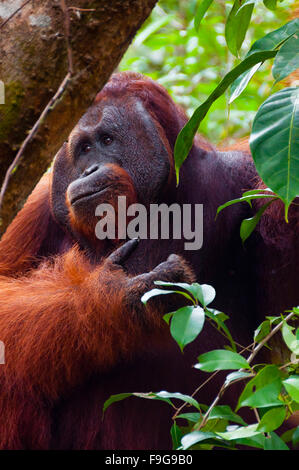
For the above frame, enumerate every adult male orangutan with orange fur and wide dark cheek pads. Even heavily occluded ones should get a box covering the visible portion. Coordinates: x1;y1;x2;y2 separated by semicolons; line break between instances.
0;73;299;449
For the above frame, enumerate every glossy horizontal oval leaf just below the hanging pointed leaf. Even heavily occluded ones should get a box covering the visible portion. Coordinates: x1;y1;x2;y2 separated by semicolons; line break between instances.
194;349;250;372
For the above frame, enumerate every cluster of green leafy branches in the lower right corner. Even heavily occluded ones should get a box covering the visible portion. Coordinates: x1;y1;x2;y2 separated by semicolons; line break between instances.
104;282;299;450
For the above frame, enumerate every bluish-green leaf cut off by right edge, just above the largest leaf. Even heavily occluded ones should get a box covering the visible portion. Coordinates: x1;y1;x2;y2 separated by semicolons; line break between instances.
272;34;299;83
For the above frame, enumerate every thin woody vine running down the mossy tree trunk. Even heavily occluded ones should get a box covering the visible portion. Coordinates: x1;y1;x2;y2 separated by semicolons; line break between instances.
0;0;73;209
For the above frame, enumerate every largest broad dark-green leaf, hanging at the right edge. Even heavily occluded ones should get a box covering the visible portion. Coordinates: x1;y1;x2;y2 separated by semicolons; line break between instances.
250;88;299;219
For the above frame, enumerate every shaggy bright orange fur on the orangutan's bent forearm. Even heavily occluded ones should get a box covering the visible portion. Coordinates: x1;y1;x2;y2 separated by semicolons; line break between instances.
0;242;171;449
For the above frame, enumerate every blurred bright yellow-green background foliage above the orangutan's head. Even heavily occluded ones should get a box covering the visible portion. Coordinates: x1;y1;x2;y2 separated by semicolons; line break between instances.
118;0;296;144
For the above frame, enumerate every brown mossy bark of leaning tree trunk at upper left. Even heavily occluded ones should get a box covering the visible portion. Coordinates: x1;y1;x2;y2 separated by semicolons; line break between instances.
0;0;157;234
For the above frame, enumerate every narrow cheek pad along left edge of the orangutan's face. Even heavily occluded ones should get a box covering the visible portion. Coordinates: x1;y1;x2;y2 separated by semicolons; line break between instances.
50;142;72;231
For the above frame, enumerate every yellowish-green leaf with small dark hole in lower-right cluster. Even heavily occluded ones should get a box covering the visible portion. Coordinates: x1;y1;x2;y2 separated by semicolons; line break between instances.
237;365;283;410
